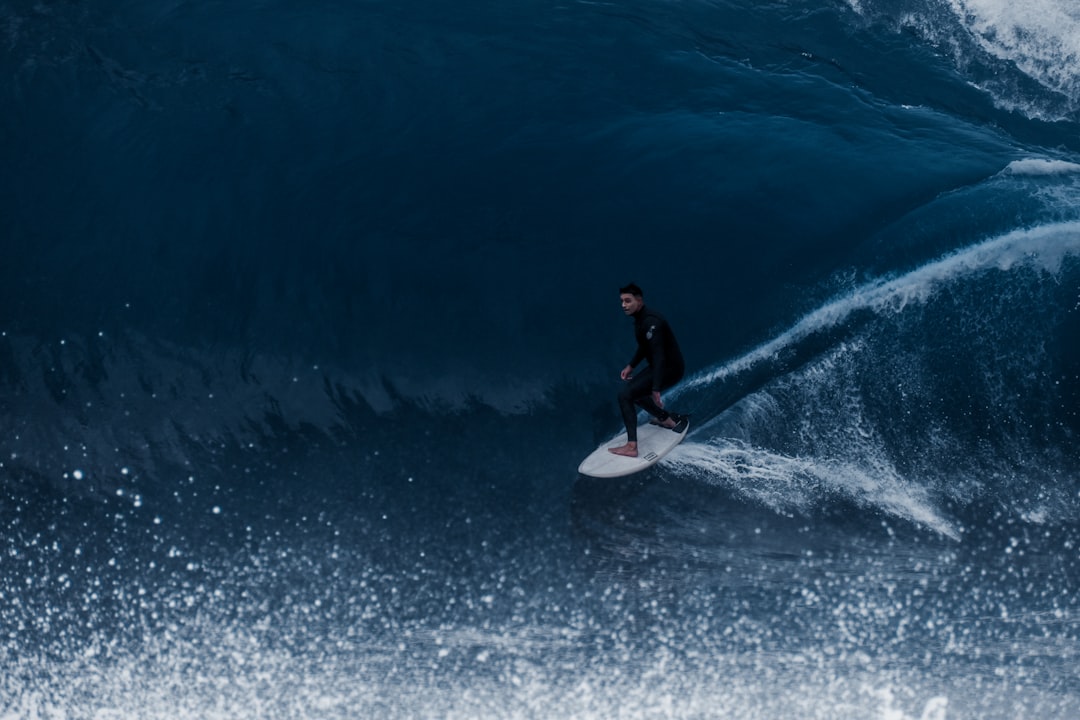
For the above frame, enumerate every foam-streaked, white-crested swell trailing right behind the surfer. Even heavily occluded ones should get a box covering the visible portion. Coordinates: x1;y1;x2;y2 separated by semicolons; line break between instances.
667;222;1080;539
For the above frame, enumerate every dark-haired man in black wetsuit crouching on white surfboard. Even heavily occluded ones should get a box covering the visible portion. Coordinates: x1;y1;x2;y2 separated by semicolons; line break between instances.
609;283;686;458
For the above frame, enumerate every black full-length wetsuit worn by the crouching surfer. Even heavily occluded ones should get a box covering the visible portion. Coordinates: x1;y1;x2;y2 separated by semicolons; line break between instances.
619;307;686;443
